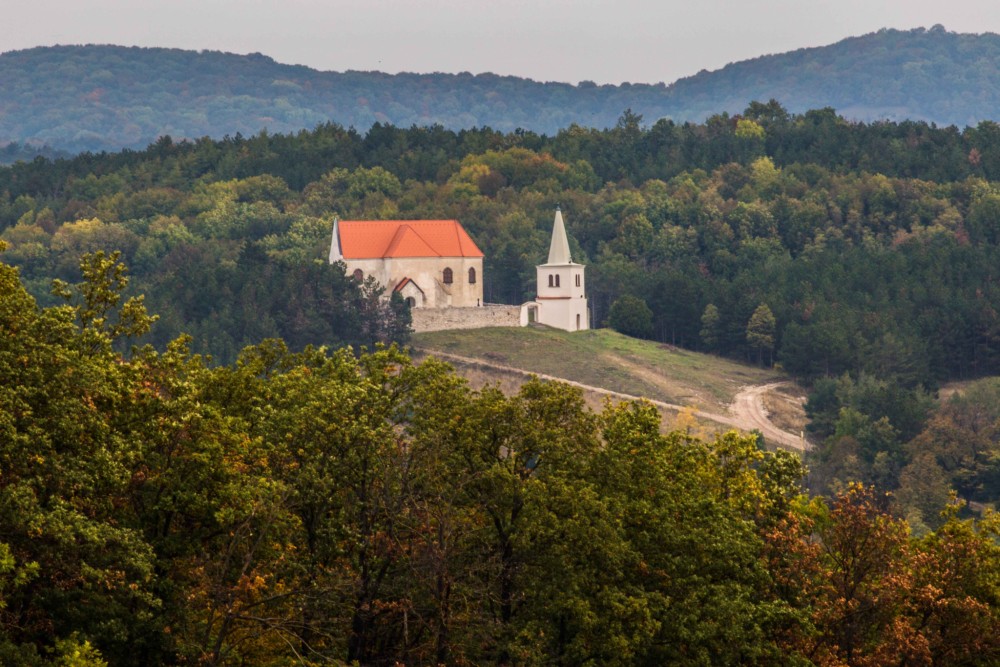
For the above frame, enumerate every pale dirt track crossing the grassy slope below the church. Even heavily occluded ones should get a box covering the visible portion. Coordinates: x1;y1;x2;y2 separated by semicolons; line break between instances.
418;349;809;451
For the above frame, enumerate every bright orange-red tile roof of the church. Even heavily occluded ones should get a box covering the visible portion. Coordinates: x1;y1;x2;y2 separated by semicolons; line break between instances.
338;220;483;259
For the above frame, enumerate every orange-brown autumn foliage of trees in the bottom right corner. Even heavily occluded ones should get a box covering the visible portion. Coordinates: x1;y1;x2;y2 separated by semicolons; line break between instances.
766;484;1000;667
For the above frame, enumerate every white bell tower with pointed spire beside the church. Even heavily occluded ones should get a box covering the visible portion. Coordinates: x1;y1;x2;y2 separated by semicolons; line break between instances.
536;206;590;331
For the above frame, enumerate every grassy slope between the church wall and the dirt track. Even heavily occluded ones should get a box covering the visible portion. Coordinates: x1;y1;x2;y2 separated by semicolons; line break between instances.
412;328;783;412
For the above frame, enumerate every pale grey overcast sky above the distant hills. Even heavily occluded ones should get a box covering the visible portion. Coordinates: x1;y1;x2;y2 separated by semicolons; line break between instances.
7;0;1000;83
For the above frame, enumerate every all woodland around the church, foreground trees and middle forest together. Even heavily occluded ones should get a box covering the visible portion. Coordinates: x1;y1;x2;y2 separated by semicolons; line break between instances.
0;105;1000;665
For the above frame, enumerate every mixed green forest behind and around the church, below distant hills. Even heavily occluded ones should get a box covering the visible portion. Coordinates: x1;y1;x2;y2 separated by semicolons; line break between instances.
0;101;1000;516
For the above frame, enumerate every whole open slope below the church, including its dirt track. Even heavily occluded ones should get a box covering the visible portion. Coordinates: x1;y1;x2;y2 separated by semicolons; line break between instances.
413;327;805;449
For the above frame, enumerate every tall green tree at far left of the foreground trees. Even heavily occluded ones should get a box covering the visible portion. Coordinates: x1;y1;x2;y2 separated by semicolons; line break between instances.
0;249;162;664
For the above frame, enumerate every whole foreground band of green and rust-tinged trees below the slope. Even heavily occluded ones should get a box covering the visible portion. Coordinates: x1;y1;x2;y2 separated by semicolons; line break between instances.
0;254;1000;666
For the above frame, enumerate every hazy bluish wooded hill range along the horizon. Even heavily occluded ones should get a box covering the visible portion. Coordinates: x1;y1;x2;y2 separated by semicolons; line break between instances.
0;26;1000;154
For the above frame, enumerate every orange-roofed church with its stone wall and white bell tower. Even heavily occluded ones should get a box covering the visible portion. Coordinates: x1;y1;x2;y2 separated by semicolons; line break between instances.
329;207;590;331
